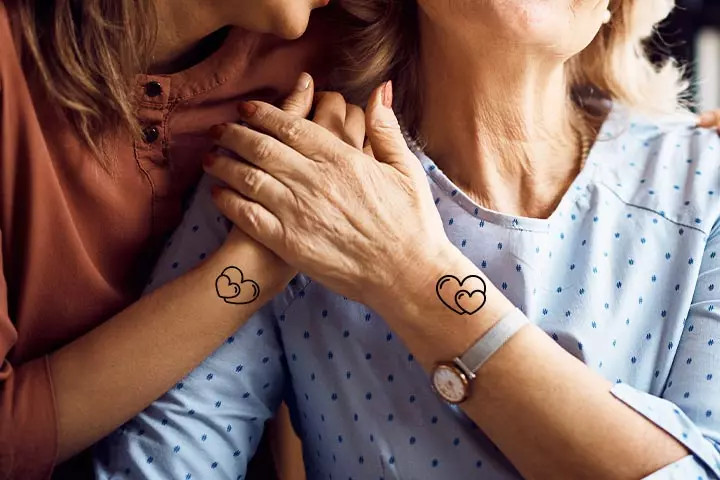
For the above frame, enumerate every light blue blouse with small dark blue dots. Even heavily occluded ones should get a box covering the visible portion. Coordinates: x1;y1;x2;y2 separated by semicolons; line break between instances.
95;107;720;480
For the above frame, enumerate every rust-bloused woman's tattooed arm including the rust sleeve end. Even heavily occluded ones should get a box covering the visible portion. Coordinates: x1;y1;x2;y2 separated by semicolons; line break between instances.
0;75;312;478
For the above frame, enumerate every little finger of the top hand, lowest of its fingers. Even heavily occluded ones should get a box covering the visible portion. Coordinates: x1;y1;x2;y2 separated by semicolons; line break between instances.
212;186;282;250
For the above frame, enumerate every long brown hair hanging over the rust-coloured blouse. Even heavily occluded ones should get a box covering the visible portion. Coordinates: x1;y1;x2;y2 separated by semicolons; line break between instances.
16;0;156;158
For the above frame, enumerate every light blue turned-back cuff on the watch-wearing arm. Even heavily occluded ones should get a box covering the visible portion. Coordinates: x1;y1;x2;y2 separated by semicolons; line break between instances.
610;383;720;480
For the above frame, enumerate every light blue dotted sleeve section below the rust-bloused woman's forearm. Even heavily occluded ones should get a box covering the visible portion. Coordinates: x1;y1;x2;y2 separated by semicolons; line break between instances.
95;298;285;479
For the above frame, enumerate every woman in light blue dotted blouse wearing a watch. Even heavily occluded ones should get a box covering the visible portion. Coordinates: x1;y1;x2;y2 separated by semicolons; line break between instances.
97;0;720;479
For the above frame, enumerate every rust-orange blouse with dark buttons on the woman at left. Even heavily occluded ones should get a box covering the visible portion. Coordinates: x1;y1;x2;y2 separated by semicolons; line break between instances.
0;0;324;479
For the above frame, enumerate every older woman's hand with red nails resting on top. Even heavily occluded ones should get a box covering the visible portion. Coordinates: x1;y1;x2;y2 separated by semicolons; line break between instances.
202;80;449;306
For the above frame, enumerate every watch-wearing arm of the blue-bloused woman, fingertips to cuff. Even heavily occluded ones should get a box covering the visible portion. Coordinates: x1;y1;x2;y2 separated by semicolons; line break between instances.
201;85;720;479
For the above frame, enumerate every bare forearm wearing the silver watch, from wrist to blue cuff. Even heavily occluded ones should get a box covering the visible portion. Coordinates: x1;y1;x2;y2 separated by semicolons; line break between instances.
379;249;688;479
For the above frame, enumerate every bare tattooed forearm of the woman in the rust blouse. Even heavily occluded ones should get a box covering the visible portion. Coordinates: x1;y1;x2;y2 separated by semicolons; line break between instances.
50;244;290;461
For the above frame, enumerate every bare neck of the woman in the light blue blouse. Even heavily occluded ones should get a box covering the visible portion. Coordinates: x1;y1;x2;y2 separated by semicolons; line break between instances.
420;14;592;218
